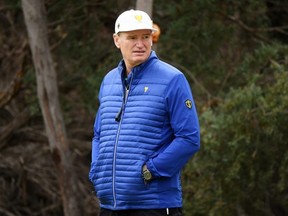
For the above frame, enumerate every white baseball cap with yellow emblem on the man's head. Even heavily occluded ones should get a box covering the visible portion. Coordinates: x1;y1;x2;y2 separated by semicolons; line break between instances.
115;9;157;34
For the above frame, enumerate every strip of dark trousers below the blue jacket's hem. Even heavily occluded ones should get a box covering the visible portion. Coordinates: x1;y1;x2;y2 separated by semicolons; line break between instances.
100;208;182;216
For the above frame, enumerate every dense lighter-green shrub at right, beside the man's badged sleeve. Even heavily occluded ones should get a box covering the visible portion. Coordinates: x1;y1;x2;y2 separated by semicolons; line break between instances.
185;45;288;215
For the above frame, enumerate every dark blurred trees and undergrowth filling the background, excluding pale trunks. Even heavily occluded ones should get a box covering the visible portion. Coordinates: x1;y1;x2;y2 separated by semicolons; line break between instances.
0;0;288;216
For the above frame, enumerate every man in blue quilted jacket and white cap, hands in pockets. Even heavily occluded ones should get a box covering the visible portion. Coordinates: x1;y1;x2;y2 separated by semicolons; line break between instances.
89;10;200;216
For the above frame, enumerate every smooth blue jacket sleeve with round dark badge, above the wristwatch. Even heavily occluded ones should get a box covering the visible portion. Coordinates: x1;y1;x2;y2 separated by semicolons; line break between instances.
147;74;200;177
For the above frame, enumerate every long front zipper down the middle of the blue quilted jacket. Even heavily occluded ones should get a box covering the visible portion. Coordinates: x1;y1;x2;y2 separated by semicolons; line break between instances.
112;74;133;208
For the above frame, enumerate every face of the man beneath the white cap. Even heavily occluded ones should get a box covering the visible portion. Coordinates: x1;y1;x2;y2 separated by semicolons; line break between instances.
114;30;152;71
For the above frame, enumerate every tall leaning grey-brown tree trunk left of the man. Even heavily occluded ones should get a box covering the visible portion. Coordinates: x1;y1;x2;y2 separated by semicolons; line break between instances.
22;0;81;216
